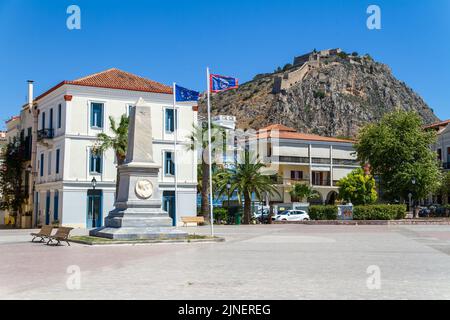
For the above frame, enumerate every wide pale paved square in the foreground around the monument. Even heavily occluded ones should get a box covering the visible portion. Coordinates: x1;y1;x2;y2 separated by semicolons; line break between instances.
0;225;450;299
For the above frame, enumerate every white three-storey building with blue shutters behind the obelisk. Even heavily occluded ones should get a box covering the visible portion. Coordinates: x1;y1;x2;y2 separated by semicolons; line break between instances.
25;69;198;228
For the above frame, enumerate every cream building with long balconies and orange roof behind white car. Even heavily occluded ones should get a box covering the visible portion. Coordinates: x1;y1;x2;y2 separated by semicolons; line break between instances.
257;124;360;204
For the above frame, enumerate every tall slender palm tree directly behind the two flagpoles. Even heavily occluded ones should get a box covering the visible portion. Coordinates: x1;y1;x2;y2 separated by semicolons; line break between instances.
188;123;224;223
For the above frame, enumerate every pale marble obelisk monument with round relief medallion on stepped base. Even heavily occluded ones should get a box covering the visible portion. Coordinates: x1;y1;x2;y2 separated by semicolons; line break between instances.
89;98;187;240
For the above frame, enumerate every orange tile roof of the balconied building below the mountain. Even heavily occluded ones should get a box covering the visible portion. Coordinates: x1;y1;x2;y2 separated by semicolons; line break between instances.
257;124;355;143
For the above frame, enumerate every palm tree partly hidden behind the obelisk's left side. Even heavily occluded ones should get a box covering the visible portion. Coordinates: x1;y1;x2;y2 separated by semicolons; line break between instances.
94;114;129;193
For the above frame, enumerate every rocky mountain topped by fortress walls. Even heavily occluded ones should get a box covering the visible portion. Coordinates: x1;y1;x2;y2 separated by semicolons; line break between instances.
200;49;439;137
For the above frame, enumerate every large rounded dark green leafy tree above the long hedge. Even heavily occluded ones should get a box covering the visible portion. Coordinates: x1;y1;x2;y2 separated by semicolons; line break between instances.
355;111;440;199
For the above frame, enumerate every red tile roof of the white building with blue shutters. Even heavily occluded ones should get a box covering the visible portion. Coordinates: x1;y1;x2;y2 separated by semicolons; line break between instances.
35;68;172;101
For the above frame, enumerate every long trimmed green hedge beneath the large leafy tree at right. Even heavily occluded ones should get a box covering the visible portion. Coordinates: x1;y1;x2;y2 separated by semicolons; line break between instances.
353;204;406;220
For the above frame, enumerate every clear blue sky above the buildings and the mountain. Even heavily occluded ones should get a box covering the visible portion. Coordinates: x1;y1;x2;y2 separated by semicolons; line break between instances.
0;0;450;128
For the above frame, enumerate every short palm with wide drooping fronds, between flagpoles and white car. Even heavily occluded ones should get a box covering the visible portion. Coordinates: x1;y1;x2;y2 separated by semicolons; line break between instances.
217;151;278;224
